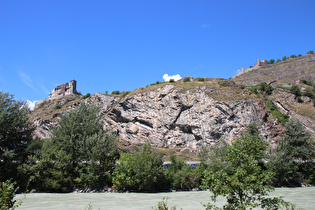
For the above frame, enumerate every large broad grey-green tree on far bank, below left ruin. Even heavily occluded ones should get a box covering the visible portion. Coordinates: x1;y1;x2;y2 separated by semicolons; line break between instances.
21;103;118;192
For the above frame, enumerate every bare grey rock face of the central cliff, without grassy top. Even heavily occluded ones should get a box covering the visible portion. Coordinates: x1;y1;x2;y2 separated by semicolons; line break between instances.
104;85;268;149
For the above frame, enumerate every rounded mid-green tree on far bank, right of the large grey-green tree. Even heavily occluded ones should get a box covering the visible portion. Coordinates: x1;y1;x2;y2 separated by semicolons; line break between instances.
113;142;166;191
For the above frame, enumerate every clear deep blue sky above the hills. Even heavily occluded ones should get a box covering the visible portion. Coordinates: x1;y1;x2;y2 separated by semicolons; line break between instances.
0;0;315;106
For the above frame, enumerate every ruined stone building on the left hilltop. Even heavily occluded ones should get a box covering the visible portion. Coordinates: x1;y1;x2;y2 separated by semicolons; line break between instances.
48;80;79;99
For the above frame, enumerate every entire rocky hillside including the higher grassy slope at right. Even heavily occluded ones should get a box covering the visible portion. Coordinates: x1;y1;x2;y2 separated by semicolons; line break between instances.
32;55;315;155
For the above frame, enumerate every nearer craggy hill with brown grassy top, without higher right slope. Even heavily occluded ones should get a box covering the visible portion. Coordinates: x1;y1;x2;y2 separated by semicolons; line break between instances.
33;80;284;151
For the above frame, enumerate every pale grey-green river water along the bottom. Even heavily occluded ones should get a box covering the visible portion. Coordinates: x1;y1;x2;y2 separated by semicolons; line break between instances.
15;187;315;210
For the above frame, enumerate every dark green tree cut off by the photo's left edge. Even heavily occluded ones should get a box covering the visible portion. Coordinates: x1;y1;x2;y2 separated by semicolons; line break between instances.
0;92;34;184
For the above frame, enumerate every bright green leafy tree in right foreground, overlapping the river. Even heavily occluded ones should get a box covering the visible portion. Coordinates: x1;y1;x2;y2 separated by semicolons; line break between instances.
203;124;296;209
